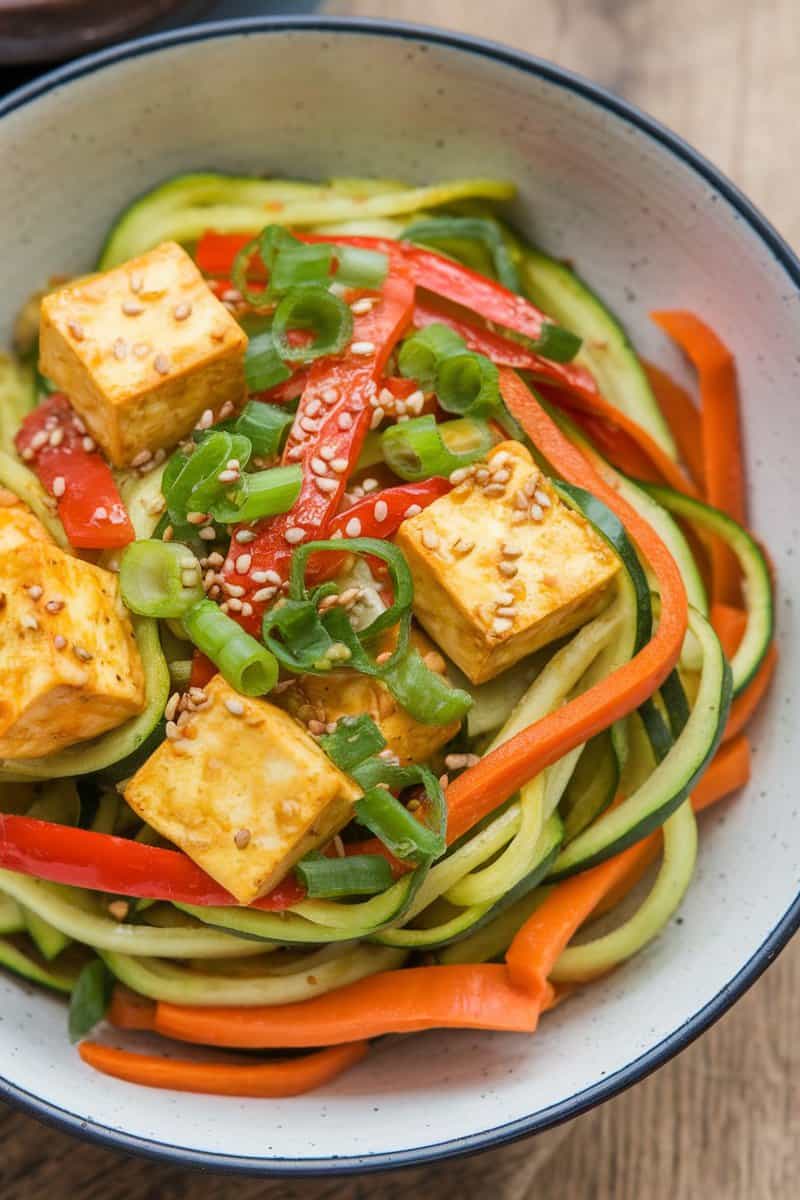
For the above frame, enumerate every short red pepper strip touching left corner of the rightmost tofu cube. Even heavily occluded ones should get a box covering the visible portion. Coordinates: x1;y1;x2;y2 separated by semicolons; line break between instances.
306;475;452;583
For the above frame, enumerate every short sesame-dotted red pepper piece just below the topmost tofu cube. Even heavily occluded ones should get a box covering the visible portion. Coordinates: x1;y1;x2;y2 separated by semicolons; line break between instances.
14;392;136;550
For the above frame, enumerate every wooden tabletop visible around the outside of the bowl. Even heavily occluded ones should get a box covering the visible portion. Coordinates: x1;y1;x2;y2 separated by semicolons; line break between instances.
0;0;800;1200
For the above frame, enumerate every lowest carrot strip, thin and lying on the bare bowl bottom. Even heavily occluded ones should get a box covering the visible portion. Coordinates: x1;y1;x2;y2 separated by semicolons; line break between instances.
78;1042;368;1098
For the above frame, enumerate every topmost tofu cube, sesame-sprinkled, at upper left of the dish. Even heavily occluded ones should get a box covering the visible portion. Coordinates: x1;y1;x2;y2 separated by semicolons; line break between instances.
40;241;247;467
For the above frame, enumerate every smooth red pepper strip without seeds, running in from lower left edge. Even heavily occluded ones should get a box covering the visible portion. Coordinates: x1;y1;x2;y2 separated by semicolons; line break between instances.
0;812;306;912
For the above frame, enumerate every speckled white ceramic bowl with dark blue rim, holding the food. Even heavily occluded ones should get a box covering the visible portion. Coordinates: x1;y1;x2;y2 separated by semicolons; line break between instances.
0;18;800;1174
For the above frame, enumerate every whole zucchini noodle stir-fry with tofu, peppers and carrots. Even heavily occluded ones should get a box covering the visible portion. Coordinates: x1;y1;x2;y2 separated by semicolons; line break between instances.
0;174;776;1097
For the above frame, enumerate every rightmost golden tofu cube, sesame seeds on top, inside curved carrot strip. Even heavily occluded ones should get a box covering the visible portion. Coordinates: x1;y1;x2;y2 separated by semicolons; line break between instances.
396;442;619;683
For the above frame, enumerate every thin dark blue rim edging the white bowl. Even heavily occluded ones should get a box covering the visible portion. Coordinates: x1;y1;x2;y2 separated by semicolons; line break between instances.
0;16;800;1177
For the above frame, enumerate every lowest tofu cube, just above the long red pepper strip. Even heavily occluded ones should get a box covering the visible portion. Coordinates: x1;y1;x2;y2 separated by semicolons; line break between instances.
125;676;361;905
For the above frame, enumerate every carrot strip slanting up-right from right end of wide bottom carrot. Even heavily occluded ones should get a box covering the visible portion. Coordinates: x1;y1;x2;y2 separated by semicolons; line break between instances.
506;833;660;995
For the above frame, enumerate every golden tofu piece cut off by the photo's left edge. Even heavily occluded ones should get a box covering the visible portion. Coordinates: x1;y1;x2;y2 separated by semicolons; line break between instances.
0;520;145;760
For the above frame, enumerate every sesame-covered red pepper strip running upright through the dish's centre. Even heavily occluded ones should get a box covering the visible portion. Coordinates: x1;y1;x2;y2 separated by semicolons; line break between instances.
223;272;414;631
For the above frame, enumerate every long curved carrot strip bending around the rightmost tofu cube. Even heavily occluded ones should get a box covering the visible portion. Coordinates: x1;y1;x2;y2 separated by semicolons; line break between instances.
447;367;688;841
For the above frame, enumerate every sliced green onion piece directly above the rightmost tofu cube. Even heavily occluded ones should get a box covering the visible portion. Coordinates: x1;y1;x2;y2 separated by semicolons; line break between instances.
381;413;494;480
